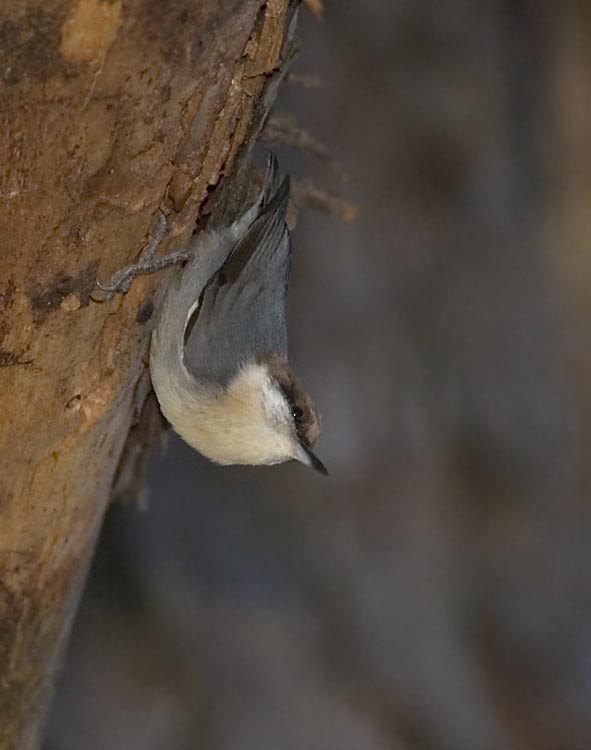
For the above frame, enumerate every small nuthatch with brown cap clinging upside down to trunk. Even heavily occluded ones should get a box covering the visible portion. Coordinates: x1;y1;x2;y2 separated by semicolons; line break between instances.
101;156;327;474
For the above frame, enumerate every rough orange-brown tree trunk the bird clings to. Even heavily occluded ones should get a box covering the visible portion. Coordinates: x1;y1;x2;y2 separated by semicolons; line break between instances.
0;0;294;749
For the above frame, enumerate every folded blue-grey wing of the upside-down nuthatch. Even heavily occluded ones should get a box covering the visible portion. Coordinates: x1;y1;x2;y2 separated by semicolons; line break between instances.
184;175;291;383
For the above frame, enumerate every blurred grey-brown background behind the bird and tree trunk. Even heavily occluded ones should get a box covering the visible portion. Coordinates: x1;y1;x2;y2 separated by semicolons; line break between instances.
46;0;591;750
